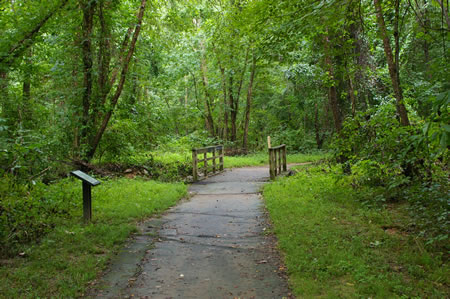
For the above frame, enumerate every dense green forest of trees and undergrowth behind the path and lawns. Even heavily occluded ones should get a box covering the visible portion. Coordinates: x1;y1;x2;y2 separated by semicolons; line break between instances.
0;0;450;298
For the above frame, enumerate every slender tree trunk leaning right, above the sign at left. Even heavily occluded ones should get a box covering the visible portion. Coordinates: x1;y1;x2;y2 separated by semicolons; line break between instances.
87;0;147;159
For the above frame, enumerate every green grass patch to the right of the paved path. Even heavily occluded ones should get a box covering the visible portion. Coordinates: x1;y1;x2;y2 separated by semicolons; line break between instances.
264;167;450;298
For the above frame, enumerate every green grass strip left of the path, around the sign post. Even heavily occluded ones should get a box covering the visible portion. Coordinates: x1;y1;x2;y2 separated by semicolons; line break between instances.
0;179;187;298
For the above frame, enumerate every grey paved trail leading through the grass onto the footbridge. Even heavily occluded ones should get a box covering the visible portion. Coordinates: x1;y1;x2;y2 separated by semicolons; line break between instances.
96;167;289;298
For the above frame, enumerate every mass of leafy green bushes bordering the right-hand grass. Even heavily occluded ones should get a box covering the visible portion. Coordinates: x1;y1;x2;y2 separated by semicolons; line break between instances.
333;104;450;244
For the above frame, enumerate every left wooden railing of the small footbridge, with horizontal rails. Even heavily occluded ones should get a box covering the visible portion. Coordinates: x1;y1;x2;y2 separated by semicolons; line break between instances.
192;145;224;182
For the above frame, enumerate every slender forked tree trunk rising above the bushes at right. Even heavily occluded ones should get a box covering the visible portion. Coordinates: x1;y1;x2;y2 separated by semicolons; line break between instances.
373;0;409;126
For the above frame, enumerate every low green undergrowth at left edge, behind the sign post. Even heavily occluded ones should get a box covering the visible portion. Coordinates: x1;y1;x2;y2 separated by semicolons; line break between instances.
0;176;80;256
